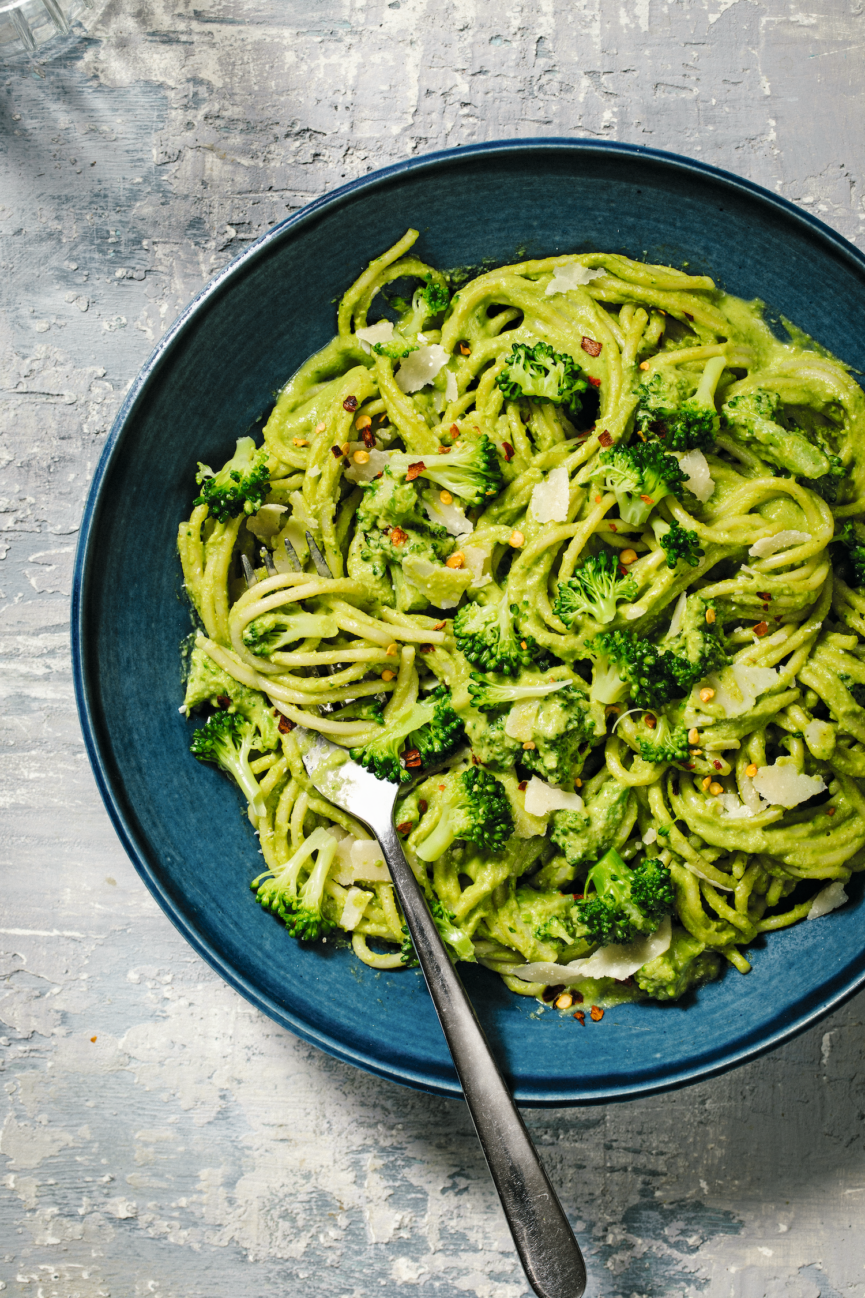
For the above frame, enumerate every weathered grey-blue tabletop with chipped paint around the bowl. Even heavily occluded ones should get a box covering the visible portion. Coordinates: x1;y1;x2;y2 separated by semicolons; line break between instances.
0;0;865;1298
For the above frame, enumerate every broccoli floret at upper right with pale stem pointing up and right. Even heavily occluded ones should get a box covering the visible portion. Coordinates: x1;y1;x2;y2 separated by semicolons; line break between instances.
636;356;726;450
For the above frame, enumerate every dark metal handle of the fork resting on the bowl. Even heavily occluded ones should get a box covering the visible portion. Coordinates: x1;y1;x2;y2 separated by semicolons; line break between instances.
370;822;586;1298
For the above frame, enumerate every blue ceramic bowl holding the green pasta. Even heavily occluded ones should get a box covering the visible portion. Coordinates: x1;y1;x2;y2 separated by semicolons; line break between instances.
73;139;865;1105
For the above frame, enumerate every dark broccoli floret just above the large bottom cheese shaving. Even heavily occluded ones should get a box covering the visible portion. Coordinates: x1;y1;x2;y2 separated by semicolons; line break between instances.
575;848;675;946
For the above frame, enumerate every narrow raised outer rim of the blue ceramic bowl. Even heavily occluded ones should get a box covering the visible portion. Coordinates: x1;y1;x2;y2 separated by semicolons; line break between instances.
70;136;865;1107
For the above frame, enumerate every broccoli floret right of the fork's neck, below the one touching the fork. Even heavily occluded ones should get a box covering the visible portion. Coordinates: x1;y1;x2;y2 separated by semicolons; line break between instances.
414;766;513;861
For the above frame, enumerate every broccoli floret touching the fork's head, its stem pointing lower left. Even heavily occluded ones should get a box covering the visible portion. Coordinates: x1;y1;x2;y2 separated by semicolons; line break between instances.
351;685;465;784
